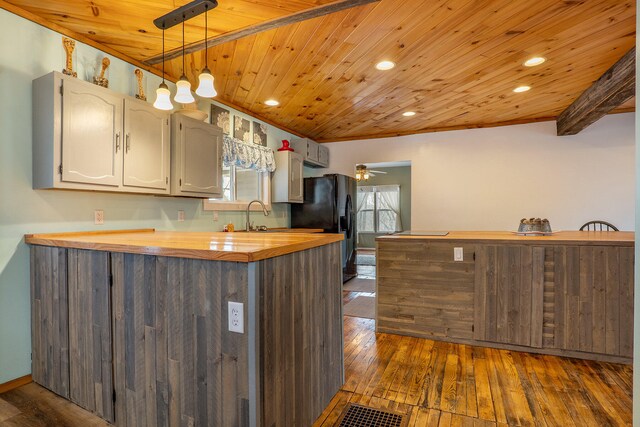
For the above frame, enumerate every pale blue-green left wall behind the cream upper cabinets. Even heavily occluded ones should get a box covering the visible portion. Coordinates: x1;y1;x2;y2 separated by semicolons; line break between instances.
0;9;291;384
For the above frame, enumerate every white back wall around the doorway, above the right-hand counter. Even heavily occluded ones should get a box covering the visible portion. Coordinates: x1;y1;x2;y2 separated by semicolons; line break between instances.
323;113;635;230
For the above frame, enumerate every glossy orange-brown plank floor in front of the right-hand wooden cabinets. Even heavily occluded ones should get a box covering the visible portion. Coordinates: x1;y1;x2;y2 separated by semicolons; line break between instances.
314;312;632;427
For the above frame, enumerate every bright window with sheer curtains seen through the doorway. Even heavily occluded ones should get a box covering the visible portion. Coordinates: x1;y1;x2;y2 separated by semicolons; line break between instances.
357;185;402;233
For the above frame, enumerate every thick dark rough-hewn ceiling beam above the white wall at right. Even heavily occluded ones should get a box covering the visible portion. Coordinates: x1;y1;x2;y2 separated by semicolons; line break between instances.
557;47;636;136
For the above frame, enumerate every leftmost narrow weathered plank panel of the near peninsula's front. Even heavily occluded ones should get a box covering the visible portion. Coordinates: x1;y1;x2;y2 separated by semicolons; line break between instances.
31;246;69;399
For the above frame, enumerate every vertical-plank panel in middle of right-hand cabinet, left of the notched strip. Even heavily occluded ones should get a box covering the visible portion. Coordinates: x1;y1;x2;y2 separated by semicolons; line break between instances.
474;245;545;347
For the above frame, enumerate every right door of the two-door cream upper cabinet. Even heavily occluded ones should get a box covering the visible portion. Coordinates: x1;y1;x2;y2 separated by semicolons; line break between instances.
123;99;171;193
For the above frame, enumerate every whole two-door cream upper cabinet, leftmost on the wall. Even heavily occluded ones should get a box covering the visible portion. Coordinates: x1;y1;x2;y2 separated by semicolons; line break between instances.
33;72;170;194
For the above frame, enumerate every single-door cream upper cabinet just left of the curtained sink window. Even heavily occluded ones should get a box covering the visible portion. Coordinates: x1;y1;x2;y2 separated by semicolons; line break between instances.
171;114;222;198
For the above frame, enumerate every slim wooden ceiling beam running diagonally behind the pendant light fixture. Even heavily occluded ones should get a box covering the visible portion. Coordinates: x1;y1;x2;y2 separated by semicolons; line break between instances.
144;0;380;65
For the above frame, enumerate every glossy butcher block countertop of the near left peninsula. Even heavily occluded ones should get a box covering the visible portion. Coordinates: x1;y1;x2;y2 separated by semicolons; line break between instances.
25;229;343;262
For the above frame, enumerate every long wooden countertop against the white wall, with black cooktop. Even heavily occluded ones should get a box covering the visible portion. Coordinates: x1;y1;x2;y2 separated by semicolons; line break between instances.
376;231;635;246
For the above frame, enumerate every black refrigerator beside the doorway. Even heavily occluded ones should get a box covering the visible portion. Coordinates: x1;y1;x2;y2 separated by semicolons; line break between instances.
291;174;358;282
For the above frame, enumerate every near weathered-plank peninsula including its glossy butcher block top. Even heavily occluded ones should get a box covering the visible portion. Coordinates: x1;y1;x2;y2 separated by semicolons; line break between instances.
26;230;344;427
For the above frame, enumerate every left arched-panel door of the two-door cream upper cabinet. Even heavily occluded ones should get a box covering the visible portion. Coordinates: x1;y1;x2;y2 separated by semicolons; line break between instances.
62;79;122;187
